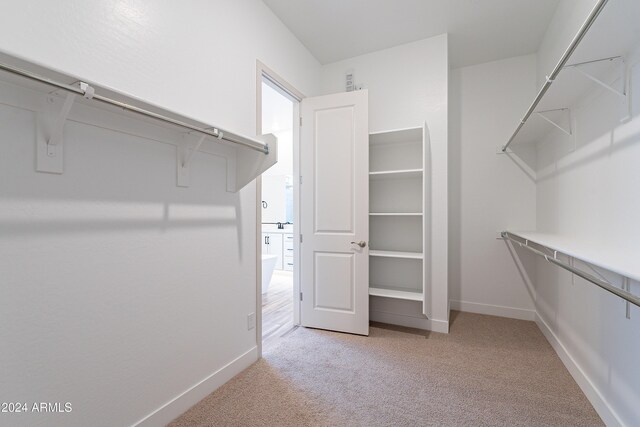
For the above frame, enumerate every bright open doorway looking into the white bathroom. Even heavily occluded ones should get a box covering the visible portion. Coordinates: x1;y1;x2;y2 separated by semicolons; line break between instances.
256;62;302;352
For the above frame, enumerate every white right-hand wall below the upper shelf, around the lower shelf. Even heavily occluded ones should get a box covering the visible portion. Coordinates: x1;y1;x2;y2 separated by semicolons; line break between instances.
537;43;640;426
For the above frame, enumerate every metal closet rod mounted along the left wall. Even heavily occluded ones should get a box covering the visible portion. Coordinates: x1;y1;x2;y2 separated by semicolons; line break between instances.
0;63;269;154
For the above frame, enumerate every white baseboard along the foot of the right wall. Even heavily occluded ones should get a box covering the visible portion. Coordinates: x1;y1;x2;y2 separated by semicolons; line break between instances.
535;313;624;427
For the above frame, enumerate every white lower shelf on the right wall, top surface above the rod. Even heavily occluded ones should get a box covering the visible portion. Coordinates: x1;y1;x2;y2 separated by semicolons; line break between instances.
509;231;640;281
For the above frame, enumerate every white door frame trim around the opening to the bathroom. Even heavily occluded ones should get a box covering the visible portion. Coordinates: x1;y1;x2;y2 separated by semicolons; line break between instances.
256;60;305;358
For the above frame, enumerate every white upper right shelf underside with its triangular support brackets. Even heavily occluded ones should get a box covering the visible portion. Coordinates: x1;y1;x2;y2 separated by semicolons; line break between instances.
505;0;640;148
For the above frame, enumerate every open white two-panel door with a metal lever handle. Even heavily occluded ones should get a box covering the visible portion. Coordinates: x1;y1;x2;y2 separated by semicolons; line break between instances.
300;91;369;335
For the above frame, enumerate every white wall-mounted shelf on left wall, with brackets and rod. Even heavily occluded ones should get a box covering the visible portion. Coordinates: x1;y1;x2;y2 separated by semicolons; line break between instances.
0;53;278;192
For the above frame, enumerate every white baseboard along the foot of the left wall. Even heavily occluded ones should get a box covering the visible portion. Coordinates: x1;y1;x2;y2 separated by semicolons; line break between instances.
133;347;258;427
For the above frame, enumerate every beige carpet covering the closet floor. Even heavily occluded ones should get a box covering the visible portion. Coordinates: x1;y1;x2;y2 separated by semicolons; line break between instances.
171;312;602;427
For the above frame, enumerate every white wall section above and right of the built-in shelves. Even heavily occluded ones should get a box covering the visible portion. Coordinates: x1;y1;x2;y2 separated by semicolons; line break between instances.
321;34;449;332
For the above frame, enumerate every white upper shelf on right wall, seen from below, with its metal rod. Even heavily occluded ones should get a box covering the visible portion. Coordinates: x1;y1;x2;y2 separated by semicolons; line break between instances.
501;0;640;151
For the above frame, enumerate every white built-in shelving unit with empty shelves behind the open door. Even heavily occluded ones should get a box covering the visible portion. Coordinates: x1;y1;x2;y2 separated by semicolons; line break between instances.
369;127;426;310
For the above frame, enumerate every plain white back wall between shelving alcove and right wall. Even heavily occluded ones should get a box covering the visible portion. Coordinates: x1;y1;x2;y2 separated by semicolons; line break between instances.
449;55;536;320
